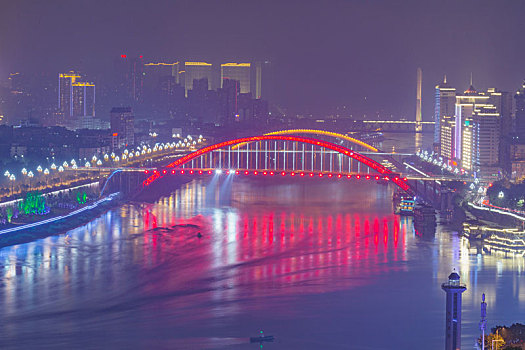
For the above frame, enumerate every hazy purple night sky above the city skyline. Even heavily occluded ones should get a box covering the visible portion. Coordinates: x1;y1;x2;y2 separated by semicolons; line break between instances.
0;0;525;120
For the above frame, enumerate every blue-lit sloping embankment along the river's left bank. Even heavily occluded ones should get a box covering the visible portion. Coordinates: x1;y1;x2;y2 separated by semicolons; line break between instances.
0;193;121;248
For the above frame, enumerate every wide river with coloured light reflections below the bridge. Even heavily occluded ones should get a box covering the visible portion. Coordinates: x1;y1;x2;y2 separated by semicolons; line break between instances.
0;133;525;349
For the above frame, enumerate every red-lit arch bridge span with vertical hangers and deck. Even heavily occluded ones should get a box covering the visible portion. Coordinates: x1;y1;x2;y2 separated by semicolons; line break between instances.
142;135;412;192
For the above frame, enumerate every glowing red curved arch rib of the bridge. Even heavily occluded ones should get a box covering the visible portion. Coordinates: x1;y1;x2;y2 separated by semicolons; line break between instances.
143;135;410;191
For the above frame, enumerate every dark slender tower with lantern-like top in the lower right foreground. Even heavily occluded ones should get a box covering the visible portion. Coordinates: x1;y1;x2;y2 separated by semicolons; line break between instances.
441;272;467;350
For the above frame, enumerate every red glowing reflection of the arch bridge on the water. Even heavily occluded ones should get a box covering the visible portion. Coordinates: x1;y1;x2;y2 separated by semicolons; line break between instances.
140;211;407;295
